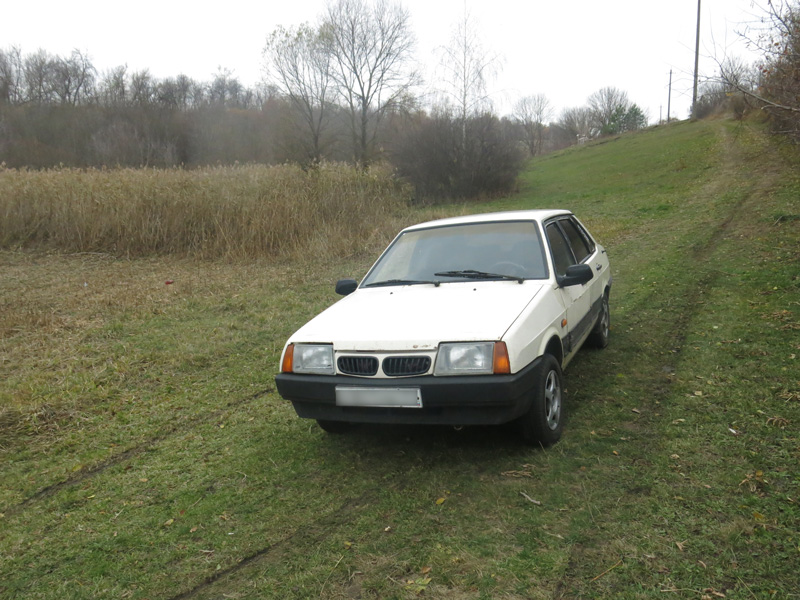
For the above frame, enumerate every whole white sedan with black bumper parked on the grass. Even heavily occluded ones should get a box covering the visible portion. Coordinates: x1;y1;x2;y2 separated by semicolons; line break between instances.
275;210;611;446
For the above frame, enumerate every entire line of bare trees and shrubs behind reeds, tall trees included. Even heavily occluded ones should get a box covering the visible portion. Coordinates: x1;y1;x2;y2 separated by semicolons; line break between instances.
0;0;647;200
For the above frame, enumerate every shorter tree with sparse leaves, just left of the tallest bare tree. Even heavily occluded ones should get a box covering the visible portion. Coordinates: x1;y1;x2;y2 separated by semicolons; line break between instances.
264;25;333;161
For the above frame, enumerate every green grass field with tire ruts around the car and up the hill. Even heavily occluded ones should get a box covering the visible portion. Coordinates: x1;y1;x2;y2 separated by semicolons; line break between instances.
0;115;800;600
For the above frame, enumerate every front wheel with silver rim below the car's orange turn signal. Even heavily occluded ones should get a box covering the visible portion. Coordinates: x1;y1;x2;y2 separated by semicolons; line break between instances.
520;354;564;447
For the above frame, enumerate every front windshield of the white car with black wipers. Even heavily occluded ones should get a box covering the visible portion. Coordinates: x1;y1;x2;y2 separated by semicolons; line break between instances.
362;221;548;287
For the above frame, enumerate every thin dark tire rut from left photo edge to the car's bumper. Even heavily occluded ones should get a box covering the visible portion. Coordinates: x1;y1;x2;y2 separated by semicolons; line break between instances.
0;387;275;515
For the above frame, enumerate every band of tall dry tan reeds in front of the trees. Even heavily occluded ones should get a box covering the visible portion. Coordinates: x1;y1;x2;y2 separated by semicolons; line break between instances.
0;164;410;259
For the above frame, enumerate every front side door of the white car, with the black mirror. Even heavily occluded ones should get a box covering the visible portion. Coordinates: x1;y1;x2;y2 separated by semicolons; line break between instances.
545;218;596;357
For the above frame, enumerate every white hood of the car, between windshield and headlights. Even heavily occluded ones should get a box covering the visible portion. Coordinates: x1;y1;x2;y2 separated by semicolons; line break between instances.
289;280;543;351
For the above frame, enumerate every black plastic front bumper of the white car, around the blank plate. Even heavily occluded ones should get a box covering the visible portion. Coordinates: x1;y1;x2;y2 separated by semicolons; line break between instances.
275;358;541;425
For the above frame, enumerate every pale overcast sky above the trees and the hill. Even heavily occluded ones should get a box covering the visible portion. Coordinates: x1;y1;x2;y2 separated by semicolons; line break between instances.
0;0;763;122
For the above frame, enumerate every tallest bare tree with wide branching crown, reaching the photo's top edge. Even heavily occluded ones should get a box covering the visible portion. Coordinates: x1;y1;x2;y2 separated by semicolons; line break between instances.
321;0;417;167
